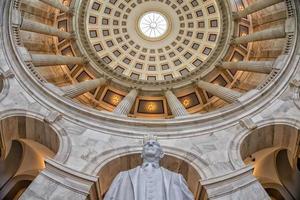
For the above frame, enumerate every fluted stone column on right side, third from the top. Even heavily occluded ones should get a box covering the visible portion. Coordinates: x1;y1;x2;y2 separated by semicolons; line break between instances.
217;61;274;74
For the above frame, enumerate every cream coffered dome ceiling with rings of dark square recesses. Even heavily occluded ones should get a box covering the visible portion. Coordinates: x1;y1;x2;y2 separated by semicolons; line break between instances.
80;1;225;85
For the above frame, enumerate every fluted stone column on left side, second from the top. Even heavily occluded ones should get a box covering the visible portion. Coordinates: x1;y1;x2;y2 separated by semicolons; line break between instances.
21;18;72;39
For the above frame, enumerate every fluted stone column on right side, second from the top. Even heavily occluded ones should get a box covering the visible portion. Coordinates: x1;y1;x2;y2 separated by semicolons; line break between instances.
233;24;286;44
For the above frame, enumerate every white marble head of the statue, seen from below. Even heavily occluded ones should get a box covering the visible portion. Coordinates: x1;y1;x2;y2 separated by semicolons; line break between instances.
141;136;164;162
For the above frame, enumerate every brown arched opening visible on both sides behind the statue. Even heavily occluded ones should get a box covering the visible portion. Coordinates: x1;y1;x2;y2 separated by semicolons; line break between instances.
98;154;200;200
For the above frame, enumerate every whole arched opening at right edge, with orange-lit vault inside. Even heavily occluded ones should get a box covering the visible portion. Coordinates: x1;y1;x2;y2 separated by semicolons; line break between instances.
240;124;300;200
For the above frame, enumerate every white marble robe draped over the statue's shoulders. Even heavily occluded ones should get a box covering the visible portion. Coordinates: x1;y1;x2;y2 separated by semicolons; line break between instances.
104;166;194;200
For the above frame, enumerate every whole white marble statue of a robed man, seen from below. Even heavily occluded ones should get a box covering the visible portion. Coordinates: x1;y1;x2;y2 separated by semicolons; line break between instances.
104;137;194;200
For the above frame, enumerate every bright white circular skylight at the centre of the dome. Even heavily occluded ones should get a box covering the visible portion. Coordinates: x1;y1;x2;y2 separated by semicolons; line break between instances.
139;12;168;39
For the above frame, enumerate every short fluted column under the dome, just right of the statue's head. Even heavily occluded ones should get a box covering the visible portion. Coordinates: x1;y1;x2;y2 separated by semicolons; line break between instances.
165;90;189;117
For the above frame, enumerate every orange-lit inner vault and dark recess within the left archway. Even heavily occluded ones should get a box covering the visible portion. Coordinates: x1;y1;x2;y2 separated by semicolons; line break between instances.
0;139;54;199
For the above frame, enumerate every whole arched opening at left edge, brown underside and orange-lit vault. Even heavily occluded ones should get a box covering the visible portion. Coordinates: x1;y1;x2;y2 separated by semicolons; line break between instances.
0;116;59;200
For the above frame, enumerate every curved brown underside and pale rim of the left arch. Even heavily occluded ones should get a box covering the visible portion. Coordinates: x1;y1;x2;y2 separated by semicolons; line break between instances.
0;114;70;162
